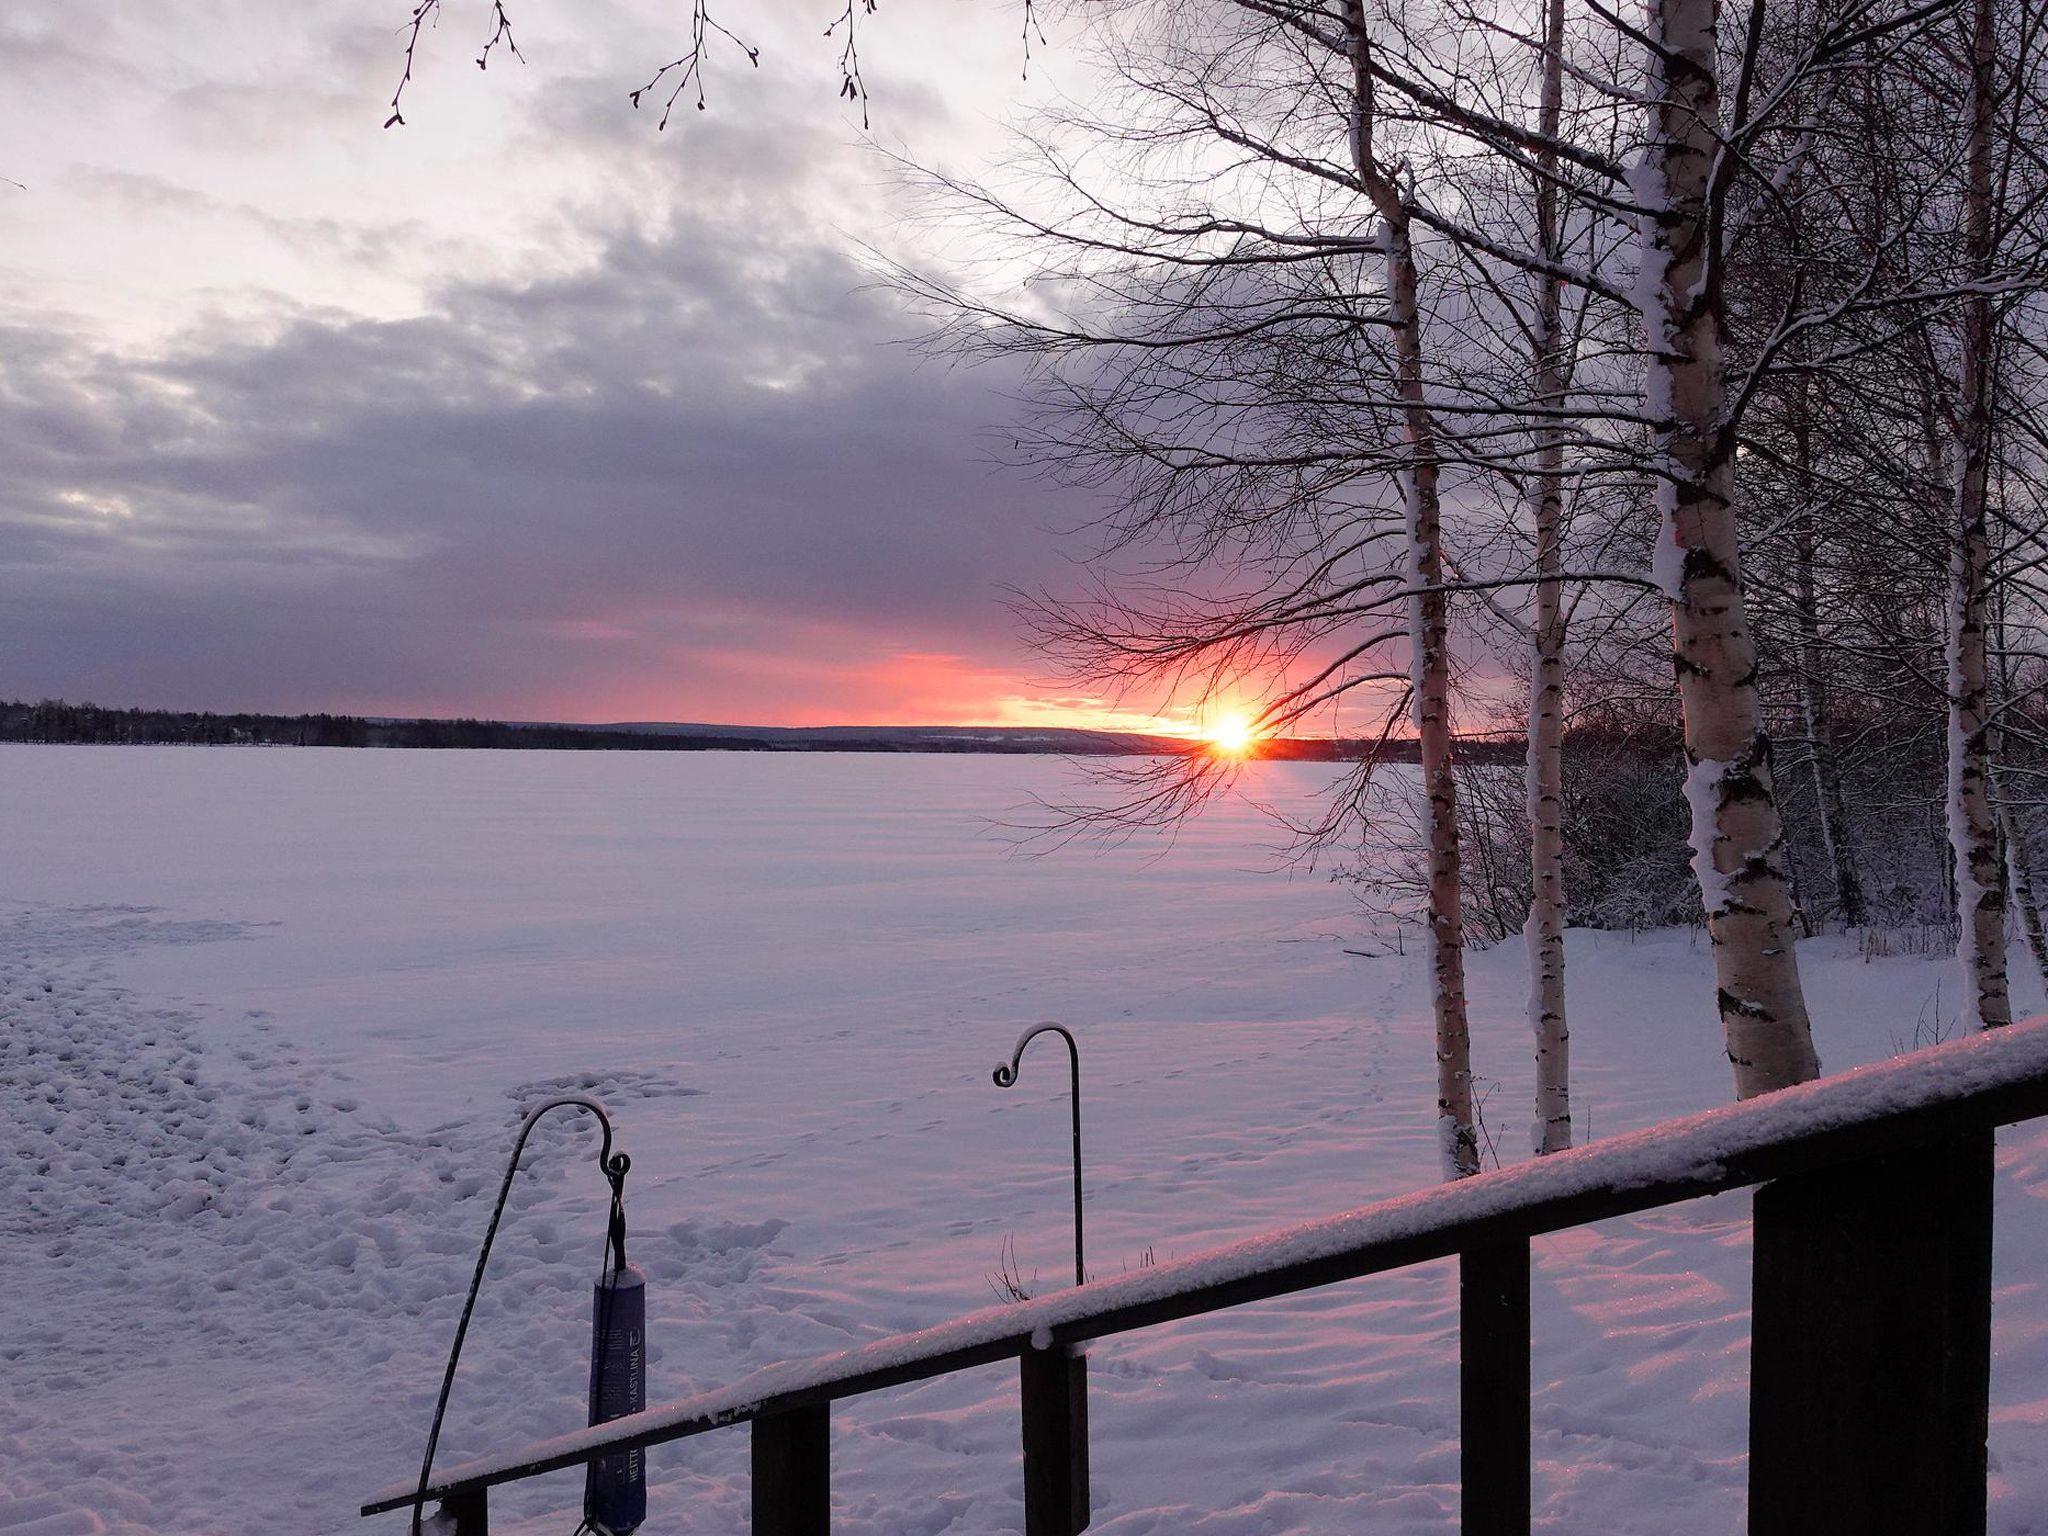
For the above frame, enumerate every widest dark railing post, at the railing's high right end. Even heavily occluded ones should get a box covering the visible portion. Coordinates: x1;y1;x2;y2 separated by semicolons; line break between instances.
1749;1128;1993;1536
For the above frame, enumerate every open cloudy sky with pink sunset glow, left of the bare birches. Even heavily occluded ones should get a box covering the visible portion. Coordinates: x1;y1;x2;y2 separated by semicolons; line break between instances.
0;0;1163;723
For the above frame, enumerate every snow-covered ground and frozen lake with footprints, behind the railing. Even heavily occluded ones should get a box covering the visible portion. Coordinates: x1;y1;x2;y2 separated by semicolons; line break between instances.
0;748;2048;1536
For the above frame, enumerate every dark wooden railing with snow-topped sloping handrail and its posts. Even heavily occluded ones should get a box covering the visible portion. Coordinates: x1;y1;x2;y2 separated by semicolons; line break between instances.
362;1018;2048;1536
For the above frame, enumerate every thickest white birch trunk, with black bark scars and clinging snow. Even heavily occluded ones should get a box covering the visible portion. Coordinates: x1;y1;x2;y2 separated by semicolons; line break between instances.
1634;0;1821;1098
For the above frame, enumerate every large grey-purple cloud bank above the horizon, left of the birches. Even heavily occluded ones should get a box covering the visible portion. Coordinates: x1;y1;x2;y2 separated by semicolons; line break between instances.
0;202;1083;713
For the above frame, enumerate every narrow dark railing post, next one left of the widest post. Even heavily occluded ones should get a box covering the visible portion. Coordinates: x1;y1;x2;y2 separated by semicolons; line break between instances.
1458;1241;1530;1536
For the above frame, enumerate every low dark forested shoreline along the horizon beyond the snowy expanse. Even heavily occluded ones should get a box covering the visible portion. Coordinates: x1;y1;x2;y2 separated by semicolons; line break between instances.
0;698;1413;762
